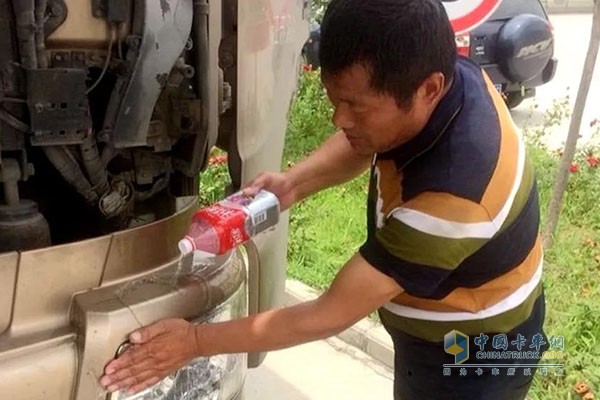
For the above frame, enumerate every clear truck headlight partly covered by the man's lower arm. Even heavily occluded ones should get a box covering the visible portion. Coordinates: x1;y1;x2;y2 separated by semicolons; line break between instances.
111;268;248;400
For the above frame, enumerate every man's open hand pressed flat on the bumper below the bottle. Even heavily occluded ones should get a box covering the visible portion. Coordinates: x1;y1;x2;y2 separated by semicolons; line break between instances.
100;319;199;394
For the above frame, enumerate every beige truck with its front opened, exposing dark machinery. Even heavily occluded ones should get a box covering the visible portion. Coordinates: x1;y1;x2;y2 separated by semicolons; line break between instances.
0;0;310;400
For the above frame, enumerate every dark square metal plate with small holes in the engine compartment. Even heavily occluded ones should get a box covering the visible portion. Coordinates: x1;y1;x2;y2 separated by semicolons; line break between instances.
27;68;91;146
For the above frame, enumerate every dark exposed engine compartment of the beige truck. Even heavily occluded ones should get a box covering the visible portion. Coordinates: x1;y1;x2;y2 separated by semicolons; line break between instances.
0;0;226;248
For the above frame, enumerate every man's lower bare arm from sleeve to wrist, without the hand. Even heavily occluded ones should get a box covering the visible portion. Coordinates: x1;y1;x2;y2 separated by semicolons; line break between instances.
196;255;402;355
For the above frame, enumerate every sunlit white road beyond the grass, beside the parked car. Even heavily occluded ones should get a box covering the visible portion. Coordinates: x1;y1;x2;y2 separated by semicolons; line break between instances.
512;14;600;146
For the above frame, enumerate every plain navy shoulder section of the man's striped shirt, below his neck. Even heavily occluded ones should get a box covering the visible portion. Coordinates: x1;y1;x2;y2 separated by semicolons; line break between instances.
403;58;517;202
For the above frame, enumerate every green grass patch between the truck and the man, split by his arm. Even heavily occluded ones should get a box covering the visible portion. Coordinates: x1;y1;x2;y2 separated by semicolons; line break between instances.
283;71;368;289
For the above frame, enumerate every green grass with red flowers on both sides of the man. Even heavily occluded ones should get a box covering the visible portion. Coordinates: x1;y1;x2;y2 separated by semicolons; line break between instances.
203;71;600;400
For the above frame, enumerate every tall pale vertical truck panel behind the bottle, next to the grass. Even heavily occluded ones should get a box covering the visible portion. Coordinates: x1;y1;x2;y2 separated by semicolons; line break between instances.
237;0;308;366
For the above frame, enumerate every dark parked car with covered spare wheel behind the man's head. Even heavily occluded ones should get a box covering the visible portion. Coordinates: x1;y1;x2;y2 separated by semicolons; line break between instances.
303;0;558;108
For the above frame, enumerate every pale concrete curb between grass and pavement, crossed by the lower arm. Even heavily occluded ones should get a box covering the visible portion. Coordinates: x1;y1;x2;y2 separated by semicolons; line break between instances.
284;280;394;369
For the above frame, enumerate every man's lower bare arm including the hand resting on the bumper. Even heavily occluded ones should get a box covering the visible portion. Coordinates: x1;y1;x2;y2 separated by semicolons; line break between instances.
100;255;402;392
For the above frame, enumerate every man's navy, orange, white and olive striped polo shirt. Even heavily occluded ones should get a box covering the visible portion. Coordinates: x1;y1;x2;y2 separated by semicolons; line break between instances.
360;58;543;342
